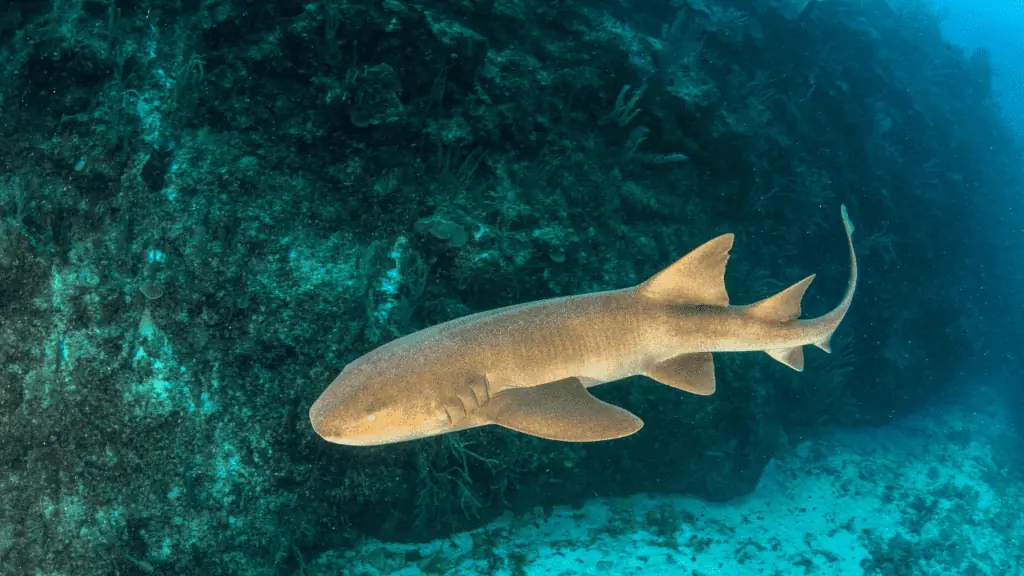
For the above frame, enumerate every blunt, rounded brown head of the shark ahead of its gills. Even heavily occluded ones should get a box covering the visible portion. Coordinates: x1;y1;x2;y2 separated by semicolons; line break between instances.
309;365;449;446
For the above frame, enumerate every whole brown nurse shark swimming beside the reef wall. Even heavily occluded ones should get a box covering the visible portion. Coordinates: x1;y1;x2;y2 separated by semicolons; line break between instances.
309;206;857;446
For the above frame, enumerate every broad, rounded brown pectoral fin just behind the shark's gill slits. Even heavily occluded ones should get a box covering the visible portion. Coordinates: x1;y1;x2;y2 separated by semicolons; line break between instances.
484;378;643;442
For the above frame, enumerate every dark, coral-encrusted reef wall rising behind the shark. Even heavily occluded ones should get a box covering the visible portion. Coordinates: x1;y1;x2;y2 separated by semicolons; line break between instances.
0;0;1021;575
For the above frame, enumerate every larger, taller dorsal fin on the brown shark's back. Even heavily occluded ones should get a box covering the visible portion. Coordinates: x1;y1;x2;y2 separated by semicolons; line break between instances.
638;234;734;306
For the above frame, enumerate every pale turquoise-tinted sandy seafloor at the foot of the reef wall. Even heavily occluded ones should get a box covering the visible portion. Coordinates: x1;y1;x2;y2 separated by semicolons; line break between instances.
315;394;1024;576
